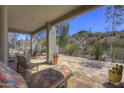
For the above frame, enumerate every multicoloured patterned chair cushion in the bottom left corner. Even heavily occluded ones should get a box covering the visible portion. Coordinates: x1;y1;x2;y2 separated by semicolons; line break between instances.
0;62;27;88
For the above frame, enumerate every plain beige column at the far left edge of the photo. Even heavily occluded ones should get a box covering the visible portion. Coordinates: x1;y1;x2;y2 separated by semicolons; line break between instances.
0;5;8;64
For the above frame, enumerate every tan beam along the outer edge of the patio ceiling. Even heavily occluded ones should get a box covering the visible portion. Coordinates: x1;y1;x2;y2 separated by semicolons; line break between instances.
32;5;101;33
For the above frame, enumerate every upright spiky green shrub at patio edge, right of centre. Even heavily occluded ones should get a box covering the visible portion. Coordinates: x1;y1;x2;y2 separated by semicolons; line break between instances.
92;42;103;60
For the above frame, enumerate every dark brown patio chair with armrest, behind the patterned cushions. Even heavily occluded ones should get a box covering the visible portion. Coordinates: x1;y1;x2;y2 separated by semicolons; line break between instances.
16;55;38;76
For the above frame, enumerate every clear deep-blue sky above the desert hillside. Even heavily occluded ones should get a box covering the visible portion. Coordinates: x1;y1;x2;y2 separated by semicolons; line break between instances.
69;7;124;35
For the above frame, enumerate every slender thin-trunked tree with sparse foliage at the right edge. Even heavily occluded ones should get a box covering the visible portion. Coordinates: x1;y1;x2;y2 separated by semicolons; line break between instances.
105;5;124;59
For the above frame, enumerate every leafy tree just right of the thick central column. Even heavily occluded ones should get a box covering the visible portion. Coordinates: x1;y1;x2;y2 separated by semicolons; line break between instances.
56;22;69;53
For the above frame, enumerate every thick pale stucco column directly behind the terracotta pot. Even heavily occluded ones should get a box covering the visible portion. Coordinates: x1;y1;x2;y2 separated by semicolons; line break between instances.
47;23;58;64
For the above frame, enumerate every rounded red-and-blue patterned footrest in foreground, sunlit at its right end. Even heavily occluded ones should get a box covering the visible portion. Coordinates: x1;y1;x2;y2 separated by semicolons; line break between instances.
25;66;72;88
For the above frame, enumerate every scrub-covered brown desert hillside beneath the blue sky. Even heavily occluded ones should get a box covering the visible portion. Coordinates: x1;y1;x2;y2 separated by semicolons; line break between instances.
64;30;124;61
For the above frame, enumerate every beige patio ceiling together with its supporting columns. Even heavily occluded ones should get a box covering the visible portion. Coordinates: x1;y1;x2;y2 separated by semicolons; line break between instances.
0;5;100;64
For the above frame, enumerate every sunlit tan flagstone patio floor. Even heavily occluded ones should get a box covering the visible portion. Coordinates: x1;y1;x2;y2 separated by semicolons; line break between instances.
32;55;124;88
